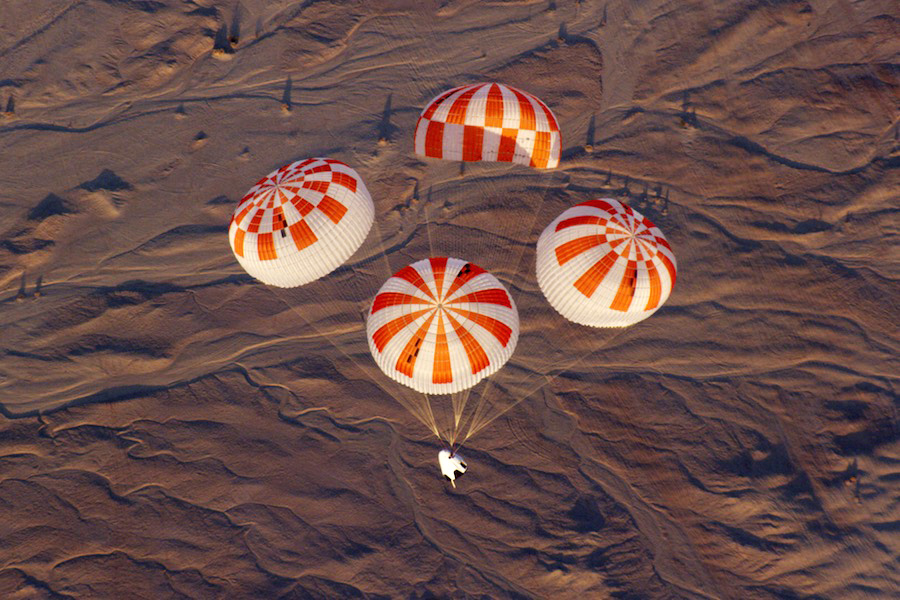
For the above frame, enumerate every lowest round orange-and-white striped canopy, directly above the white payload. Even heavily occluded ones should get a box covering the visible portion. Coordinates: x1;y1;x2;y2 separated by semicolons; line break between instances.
366;257;519;394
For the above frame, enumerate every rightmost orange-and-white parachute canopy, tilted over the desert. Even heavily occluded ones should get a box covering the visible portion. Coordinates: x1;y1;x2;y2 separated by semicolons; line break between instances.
537;198;677;327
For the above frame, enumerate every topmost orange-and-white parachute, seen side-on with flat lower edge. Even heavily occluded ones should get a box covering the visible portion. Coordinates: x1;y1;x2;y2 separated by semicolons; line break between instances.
415;83;562;169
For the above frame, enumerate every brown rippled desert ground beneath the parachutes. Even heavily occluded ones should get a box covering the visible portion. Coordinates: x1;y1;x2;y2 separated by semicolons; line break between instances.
0;0;900;599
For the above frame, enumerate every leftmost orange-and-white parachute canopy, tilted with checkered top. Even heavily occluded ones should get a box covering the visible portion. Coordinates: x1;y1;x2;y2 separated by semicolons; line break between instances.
228;158;375;287
